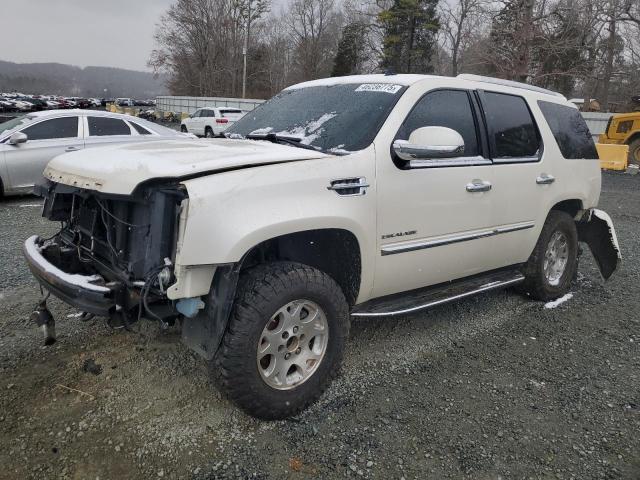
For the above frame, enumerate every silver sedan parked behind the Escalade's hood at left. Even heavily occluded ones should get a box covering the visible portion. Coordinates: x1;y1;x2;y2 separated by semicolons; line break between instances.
0;110;193;197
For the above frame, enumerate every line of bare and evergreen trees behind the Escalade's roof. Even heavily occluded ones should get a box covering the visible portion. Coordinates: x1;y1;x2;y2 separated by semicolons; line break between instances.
149;0;640;110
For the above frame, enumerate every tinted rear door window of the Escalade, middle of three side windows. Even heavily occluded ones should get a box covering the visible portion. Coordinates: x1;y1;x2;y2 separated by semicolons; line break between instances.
483;92;540;158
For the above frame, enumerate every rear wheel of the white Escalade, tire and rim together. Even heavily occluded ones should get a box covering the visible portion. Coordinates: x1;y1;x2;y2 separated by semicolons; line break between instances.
520;210;578;301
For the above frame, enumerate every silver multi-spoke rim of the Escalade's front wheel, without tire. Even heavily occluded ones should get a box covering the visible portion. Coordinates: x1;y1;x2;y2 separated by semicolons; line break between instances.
257;299;329;390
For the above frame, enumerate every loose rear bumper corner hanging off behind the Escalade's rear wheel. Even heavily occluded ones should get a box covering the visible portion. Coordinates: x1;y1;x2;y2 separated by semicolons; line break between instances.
576;208;622;280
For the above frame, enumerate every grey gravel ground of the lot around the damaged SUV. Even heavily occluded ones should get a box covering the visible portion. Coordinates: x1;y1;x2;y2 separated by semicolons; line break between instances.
0;175;640;480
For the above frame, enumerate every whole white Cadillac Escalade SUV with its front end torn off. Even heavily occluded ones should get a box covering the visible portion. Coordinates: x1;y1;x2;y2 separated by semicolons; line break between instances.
24;75;620;419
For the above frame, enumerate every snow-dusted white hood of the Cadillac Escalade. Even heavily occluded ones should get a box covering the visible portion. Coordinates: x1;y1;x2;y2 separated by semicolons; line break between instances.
44;139;328;195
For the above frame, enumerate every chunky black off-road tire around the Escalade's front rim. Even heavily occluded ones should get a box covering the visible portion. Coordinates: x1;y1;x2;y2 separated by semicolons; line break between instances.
211;262;349;420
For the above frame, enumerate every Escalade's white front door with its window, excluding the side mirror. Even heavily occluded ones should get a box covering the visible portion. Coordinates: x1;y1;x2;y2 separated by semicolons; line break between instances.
373;89;495;297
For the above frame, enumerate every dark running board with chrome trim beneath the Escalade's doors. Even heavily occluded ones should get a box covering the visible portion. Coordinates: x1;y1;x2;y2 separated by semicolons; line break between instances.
351;269;524;317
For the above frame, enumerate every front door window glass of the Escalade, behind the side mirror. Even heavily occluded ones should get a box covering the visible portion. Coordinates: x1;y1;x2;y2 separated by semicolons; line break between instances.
396;90;479;157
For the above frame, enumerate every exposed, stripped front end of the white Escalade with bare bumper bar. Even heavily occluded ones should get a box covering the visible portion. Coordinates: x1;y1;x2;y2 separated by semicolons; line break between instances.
24;180;188;327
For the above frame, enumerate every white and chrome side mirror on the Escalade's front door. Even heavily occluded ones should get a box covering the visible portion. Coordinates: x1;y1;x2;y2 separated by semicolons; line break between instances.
393;127;464;161
